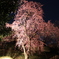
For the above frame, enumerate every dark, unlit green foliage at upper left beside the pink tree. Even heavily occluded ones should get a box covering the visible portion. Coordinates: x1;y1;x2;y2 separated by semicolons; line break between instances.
0;0;18;41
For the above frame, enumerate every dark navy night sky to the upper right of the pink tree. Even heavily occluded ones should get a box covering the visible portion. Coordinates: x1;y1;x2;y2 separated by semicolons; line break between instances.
29;0;59;22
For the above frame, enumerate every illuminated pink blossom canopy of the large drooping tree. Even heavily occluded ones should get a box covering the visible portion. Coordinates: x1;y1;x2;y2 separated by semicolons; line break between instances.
6;1;59;59
